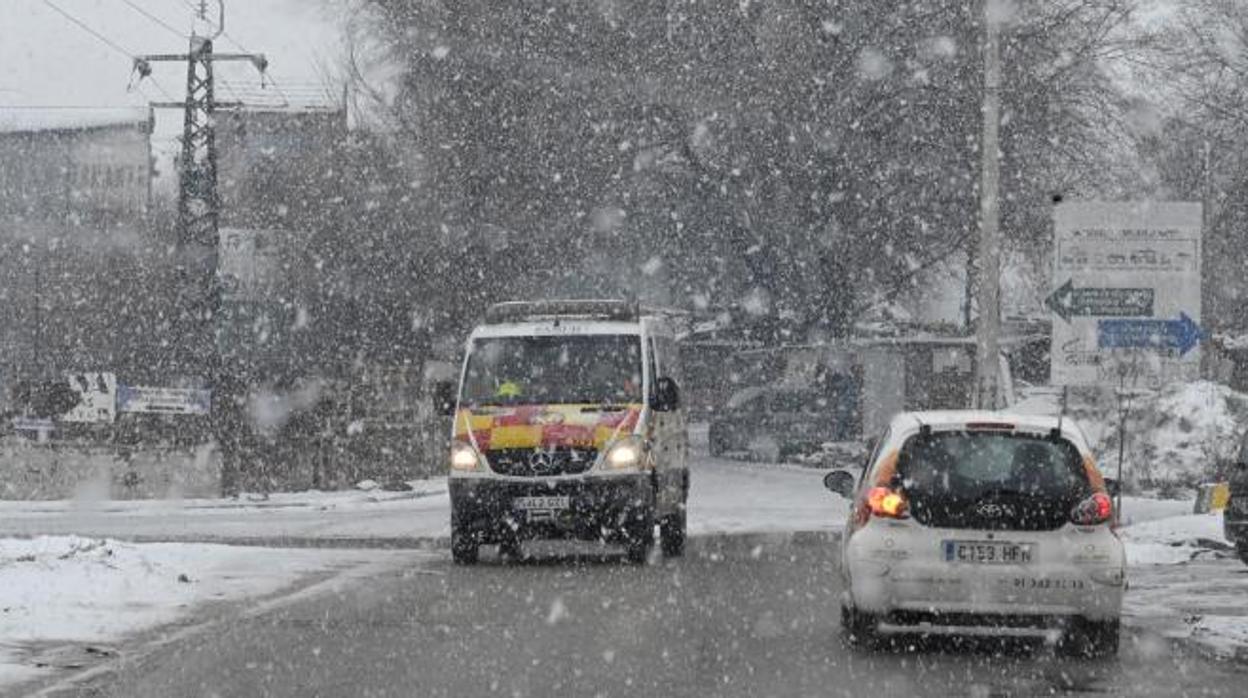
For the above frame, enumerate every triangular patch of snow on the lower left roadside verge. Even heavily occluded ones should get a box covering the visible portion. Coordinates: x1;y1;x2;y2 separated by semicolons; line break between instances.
0;536;409;687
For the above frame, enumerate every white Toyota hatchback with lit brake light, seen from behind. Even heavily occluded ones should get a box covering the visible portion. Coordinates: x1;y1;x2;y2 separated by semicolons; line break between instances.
825;411;1126;656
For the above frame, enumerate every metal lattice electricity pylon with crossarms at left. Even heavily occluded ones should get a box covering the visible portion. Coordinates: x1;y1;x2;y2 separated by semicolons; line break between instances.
135;0;268;493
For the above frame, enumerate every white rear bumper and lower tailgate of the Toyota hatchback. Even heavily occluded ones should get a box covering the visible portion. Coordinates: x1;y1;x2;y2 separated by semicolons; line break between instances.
844;522;1127;619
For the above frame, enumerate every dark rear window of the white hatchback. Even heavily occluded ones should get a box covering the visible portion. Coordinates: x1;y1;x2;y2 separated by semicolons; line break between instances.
897;432;1090;498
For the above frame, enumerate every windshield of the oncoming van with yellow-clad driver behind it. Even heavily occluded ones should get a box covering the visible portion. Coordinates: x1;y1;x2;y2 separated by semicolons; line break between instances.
461;335;641;407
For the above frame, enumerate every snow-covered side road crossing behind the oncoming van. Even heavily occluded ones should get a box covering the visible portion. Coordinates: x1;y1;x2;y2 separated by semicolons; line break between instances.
0;458;847;542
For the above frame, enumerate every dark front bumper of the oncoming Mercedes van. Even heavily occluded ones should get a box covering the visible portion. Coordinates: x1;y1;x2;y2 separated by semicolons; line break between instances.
449;473;654;543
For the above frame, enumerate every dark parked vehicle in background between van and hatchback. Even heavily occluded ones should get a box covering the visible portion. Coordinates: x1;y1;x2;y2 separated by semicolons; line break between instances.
708;378;859;458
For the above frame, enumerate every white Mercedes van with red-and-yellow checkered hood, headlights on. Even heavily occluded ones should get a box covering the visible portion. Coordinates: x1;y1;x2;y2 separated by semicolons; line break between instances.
447;301;689;563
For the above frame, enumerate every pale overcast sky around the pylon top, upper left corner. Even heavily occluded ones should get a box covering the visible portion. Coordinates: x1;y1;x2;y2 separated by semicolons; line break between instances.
0;0;349;139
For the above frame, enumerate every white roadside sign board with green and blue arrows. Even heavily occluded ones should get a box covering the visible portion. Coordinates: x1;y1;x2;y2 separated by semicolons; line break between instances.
1046;201;1203;387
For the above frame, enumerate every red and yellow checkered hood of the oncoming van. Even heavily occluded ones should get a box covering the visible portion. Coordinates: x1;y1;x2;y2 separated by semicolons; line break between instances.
454;405;641;451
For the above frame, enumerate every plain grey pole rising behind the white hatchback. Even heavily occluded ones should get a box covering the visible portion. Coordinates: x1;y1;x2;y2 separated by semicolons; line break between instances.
975;0;1002;410
